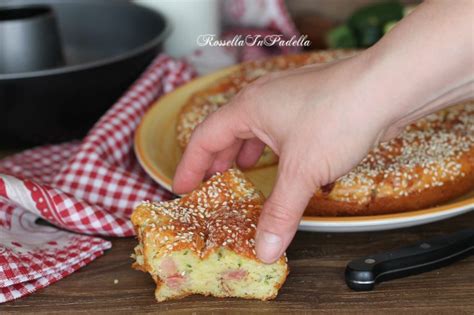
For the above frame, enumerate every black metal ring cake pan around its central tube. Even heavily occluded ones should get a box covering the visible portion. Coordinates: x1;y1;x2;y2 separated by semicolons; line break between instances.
0;0;169;148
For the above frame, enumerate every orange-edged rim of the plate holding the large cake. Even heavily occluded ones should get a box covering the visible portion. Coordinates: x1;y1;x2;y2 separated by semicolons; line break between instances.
134;65;474;226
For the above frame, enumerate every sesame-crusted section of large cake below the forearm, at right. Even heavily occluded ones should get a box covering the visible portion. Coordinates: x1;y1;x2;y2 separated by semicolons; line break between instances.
305;101;474;216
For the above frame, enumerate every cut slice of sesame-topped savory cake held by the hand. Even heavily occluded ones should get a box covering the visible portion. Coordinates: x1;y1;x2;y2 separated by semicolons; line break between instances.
132;169;288;302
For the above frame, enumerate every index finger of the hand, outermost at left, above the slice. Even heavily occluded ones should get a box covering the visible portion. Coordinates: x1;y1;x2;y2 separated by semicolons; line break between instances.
173;104;252;194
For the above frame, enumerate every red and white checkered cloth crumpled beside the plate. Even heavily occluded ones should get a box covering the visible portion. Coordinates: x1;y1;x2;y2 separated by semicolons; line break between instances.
0;0;296;303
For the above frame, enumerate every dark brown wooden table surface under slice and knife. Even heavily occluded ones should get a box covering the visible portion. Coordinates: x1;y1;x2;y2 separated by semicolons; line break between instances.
0;211;474;314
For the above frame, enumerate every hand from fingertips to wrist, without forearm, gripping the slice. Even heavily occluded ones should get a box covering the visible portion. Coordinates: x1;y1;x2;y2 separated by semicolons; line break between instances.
174;53;398;262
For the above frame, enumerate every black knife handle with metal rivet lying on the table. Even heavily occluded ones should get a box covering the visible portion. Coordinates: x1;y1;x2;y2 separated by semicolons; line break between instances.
345;228;474;291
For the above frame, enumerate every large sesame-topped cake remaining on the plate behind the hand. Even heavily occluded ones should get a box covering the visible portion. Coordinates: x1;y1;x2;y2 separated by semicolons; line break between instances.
176;51;474;216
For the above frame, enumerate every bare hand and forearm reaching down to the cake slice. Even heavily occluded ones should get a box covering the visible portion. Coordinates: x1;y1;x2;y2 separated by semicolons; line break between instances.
173;1;474;262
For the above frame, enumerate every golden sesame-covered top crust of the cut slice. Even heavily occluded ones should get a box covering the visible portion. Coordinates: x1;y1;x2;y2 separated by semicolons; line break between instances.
134;170;263;258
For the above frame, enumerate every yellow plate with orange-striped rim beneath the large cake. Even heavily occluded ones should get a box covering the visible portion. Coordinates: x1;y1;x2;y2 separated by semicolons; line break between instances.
135;66;474;232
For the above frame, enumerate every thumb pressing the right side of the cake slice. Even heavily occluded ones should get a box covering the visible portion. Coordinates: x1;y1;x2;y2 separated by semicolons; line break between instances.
255;161;316;263
